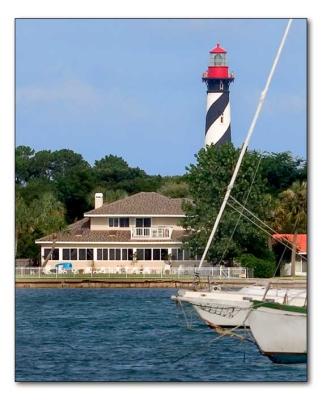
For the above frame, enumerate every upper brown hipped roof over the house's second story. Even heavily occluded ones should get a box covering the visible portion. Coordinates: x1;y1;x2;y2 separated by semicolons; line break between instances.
84;192;184;217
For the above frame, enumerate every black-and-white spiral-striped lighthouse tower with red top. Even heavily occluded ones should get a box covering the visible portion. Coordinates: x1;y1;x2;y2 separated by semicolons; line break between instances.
202;43;234;146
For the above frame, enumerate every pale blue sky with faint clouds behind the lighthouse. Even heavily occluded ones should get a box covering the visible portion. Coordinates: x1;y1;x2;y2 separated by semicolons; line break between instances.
15;19;307;175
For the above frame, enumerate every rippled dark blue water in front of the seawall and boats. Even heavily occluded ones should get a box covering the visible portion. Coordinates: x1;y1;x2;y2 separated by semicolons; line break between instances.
16;289;307;382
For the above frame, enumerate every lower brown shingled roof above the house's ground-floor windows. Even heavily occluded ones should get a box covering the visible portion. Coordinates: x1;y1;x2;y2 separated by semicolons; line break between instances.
36;218;186;244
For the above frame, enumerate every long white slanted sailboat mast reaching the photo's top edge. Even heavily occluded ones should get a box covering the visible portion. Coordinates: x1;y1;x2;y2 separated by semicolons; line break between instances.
198;19;292;269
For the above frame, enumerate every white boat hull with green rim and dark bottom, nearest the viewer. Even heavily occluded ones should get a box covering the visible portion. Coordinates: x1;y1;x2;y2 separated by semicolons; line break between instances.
248;307;307;363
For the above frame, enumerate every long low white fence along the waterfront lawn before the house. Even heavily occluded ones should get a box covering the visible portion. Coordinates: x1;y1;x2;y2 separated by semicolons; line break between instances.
16;265;252;279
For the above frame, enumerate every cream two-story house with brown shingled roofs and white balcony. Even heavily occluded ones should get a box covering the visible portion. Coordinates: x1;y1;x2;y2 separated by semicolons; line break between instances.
36;192;196;271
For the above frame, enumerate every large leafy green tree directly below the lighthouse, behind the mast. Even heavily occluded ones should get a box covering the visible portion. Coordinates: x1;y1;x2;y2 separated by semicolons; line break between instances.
183;144;269;262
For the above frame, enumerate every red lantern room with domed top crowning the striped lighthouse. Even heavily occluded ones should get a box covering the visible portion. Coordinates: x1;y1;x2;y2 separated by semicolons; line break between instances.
203;43;234;80
